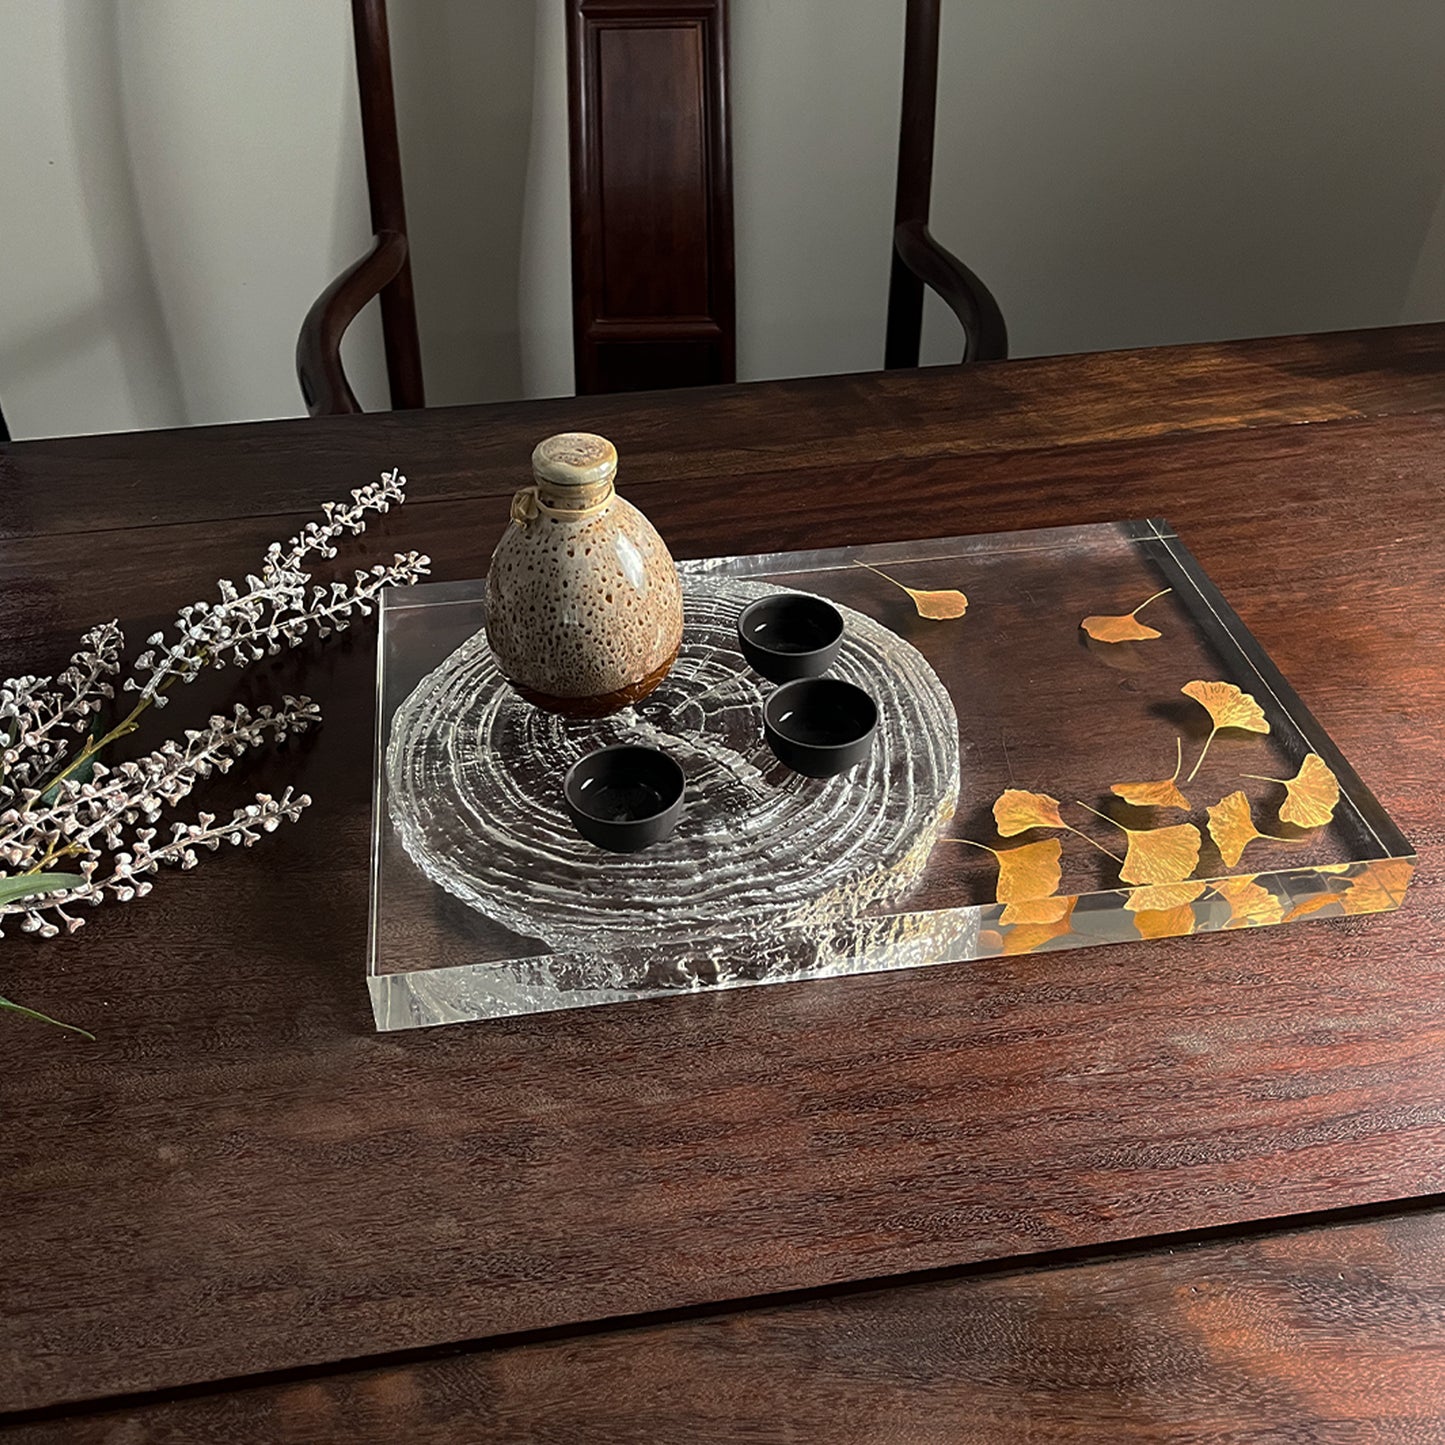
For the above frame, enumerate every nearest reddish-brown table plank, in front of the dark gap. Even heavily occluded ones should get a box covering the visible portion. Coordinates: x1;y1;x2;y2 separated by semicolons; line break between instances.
0;1212;1445;1445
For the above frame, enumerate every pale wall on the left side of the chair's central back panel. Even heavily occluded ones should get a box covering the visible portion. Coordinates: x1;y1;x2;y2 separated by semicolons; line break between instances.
0;0;557;436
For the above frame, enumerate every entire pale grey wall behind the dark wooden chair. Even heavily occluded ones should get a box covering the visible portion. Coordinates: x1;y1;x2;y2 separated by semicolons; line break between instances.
0;0;1445;436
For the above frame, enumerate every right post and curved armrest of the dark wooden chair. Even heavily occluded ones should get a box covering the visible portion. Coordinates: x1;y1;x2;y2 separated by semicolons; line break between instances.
883;0;1009;370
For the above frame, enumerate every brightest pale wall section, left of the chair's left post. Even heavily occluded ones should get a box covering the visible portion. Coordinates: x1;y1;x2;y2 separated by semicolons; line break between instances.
0;0;384;436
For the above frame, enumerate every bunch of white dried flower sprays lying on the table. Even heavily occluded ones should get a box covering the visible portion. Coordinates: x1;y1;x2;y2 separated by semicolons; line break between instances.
0;470;431;1032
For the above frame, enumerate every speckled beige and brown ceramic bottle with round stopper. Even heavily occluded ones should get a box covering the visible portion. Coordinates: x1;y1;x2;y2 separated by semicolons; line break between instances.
487;432;682;717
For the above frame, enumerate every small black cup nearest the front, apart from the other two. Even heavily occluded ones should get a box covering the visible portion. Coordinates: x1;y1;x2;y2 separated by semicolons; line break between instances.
562;744;686;853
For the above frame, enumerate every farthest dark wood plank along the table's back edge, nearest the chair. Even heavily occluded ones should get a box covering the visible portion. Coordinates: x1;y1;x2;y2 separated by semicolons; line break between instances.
8;325;1445;540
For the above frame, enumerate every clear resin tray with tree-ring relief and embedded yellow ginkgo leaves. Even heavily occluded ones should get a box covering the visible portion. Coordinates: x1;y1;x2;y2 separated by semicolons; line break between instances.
367;522;1415;1029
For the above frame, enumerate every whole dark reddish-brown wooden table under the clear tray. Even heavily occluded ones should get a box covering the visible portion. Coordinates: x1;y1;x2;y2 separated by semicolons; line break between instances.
0;328;1445;1445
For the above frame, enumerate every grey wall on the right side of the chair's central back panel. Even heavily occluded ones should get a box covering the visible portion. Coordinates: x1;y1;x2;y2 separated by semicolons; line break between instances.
733;0;1445;377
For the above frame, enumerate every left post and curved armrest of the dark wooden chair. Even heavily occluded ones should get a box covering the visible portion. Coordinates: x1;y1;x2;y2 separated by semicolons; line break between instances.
296;0;426;416
